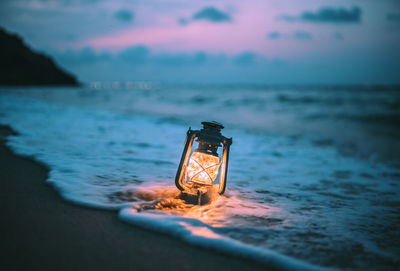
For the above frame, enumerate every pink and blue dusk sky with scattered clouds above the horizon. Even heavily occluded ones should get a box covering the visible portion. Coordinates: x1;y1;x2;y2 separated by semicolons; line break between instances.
0;0;400;85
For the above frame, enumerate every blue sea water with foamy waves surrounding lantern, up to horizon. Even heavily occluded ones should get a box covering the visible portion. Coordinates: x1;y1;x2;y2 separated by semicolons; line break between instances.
0;85;400;270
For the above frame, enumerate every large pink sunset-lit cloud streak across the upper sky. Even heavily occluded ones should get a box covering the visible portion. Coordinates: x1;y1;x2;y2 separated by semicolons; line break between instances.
78;1;350;58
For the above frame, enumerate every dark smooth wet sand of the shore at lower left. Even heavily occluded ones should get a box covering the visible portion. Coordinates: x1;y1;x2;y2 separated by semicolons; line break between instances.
0;126;272;270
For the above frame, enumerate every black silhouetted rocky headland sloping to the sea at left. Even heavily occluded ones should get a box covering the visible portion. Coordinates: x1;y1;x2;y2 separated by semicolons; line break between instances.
0;27;79;86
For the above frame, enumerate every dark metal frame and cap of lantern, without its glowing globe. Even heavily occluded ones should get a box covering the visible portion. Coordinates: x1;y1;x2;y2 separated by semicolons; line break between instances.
175;121;232;195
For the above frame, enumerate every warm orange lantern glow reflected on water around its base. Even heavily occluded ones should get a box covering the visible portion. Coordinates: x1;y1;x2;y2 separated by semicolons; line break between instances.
125;186;282;228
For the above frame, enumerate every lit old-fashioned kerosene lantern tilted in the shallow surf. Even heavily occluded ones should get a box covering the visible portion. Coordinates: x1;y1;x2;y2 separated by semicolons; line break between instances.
175;121;232;198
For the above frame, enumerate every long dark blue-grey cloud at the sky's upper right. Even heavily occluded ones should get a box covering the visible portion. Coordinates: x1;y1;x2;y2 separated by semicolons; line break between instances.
282;6;362;24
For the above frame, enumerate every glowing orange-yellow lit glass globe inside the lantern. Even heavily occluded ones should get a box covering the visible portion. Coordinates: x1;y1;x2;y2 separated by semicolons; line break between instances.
186;151;220;185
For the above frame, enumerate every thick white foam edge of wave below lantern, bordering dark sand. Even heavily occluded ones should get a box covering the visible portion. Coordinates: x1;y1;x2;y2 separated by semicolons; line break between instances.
118;207;338;271
